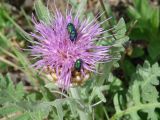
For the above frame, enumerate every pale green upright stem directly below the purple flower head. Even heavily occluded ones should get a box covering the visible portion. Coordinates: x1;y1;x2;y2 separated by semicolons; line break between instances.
70;88;91;120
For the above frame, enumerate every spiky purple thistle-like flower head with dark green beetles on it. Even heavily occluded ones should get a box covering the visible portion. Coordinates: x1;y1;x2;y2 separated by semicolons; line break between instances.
31;4;110;89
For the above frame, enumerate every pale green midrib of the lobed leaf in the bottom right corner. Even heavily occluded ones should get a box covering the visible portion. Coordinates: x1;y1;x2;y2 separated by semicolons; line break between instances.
110;103;160;120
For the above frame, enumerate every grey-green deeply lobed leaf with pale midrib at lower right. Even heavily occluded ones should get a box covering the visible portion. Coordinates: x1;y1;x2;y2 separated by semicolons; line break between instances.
112;61;160;120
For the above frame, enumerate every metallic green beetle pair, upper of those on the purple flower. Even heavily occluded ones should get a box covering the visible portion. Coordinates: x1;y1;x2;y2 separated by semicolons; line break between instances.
67;23;77;42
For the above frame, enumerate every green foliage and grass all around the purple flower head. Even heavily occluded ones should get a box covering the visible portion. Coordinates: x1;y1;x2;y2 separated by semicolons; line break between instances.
0;0;160;120
